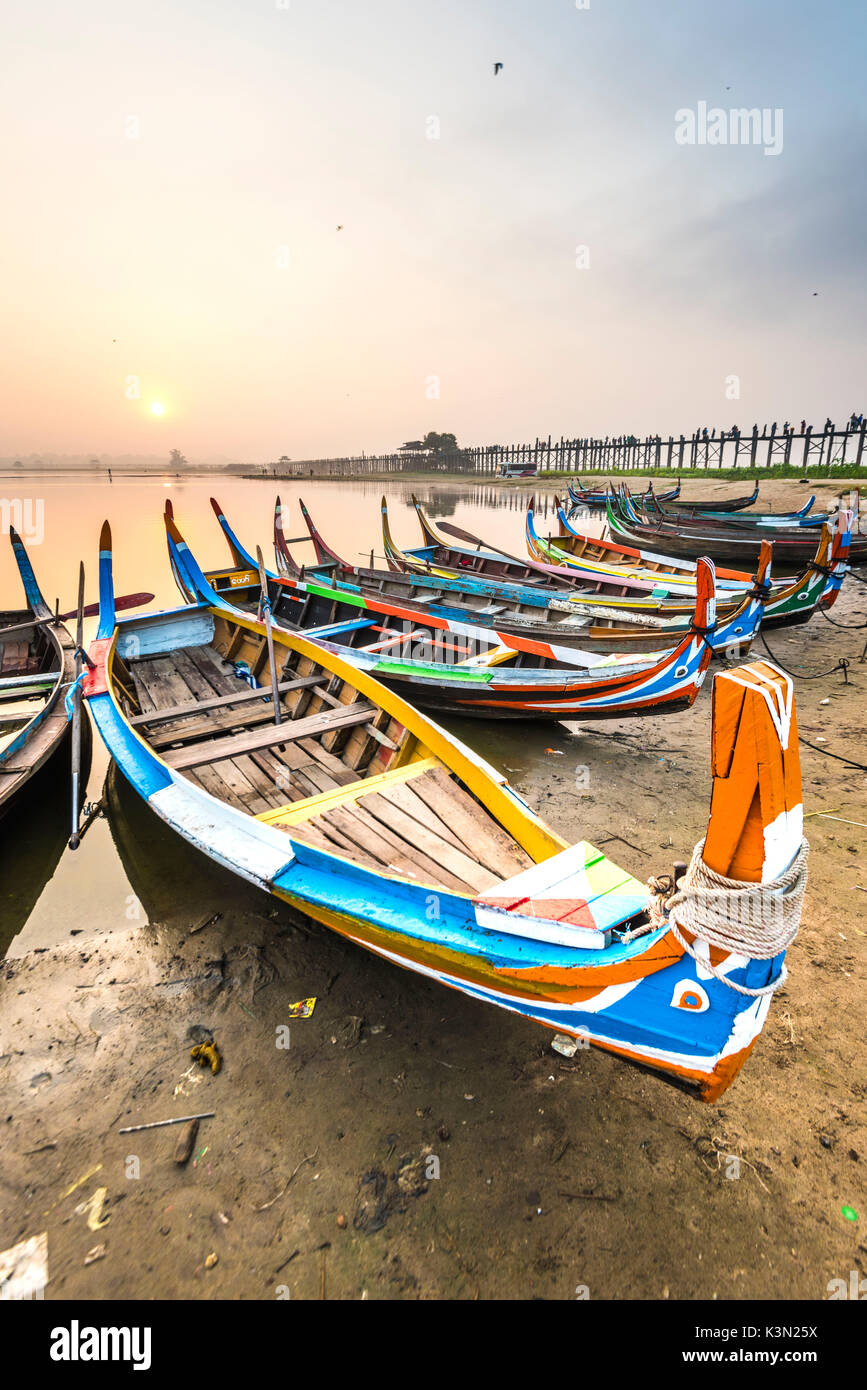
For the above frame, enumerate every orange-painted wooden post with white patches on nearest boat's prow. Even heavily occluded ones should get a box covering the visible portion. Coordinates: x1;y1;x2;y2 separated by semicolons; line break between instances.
702;660;803;883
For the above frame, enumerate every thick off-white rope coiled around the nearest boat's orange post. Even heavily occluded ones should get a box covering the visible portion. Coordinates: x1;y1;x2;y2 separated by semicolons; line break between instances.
647;840;810;998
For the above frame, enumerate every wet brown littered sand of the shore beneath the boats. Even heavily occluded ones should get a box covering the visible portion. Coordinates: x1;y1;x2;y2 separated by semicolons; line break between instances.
0;480;867;1300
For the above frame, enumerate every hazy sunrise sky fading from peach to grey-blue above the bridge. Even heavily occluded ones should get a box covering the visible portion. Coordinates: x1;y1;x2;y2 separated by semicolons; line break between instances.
0;0;867;460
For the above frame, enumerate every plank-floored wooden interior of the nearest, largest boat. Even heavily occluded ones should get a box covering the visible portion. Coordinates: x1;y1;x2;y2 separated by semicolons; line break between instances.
113;610;534;895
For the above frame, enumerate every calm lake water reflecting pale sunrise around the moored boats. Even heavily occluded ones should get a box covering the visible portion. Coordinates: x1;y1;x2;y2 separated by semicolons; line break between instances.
0;471;589;955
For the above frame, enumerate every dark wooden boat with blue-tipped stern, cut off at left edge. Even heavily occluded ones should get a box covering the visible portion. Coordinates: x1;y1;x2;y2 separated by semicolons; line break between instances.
0;528;75;816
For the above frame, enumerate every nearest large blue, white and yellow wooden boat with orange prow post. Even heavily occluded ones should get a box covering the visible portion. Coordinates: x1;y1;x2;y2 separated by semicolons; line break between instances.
83;525;800;1101
